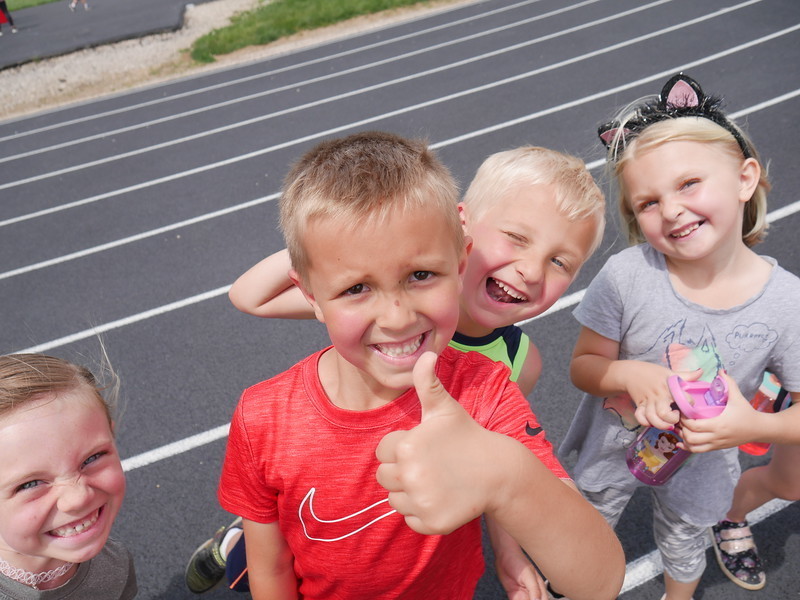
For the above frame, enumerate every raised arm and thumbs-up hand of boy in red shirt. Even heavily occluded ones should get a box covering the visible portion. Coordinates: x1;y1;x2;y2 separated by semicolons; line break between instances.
376;353;625;600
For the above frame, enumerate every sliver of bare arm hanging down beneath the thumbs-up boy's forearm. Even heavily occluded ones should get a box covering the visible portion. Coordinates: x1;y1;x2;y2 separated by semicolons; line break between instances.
486;516;548;600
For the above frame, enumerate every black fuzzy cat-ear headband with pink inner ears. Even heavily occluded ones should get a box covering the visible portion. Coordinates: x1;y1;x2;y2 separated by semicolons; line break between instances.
597;73;753;158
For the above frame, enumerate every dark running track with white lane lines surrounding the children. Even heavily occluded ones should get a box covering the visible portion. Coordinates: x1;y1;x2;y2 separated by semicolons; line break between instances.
0;0;800;600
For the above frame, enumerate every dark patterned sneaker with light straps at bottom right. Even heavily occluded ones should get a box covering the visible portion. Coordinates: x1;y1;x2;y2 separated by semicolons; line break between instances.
709;521;767;590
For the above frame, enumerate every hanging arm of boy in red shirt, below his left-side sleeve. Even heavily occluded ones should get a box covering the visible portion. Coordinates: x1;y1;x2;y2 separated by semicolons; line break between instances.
242;519;298;600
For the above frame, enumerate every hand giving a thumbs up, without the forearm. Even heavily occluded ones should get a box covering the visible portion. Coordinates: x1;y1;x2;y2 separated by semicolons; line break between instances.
375;352;512;534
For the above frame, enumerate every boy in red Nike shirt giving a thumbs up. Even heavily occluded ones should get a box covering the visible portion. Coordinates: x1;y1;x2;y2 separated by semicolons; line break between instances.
212;133;624;600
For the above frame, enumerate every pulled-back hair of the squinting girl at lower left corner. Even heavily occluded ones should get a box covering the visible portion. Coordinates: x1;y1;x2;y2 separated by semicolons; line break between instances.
0;354;119;424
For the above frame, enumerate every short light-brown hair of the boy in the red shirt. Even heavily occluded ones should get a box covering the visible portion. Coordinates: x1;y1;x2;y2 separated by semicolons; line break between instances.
280;132;464;278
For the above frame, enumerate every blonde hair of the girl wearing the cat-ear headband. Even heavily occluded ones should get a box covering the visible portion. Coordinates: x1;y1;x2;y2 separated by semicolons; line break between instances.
608;116;771;247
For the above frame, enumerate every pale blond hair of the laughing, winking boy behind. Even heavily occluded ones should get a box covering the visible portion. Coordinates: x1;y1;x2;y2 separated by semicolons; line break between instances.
464;146;606;254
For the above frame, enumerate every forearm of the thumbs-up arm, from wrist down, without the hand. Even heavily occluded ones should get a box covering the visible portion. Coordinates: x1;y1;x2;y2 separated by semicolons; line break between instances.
487;445;625;600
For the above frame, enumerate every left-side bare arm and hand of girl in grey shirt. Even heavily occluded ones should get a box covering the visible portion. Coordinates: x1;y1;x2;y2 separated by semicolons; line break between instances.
570;327;702;429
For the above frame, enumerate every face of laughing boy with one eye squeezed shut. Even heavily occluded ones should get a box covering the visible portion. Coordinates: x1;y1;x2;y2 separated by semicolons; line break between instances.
458;185;597;337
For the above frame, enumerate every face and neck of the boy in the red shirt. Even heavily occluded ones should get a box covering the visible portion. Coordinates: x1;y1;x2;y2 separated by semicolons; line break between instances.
292;203;466;410
